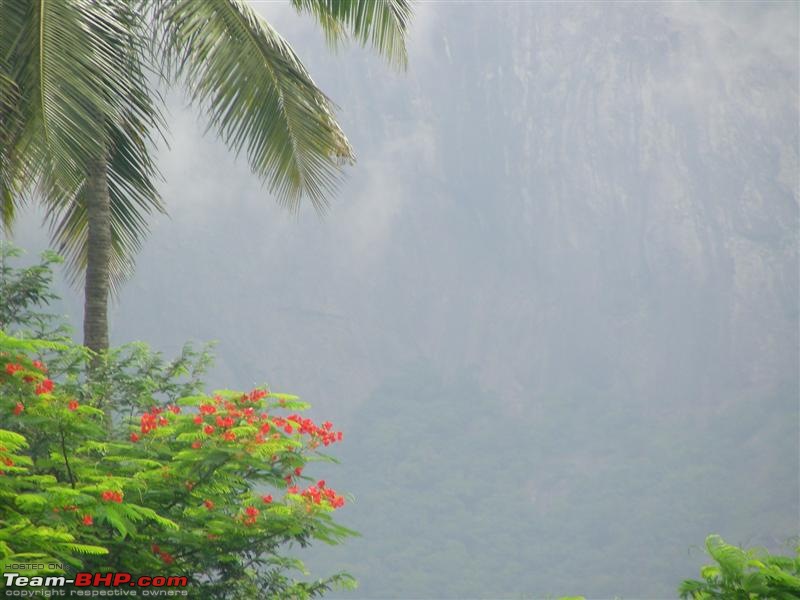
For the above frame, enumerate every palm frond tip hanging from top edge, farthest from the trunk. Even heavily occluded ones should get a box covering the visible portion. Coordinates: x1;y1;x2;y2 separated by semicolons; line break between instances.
292;0;412;68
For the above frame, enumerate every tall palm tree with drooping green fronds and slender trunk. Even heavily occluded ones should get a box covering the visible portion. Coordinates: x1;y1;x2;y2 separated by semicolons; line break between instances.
0;0;411;351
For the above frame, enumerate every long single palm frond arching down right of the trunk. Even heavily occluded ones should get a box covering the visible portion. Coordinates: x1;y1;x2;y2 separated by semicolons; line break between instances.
156;0;353;211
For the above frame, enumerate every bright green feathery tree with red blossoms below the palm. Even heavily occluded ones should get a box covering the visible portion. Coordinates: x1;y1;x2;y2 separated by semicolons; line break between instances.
0;246;354;599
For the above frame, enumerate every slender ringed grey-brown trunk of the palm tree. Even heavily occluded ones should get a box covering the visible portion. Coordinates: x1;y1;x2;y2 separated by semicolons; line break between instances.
83;153;111;352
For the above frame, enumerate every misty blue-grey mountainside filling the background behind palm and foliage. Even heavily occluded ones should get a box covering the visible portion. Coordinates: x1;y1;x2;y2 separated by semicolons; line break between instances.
9;1;800;598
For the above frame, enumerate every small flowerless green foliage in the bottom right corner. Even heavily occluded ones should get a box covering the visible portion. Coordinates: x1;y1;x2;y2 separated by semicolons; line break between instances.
678;535;800;600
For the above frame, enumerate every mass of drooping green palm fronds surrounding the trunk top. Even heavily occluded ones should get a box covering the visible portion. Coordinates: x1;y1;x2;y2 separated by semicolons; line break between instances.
0;0;165;289
